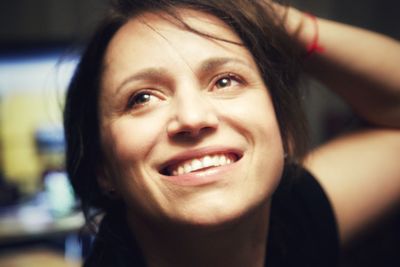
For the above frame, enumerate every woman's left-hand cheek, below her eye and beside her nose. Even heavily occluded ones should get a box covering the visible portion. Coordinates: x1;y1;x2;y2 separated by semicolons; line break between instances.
102;113;169;202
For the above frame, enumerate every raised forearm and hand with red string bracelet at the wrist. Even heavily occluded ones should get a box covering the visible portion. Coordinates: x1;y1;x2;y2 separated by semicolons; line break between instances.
286;8;400;127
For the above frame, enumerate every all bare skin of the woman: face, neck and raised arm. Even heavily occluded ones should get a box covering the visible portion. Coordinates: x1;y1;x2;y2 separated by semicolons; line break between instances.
95;3;400;266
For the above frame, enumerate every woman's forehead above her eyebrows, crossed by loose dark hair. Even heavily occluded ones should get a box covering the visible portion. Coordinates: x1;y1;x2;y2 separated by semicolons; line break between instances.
100;9;254;82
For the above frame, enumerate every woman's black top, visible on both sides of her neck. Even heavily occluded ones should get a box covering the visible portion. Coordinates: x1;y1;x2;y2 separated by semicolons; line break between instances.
84;168;339;267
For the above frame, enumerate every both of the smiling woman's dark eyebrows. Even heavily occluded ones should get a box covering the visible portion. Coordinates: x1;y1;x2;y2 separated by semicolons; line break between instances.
116;57;251;94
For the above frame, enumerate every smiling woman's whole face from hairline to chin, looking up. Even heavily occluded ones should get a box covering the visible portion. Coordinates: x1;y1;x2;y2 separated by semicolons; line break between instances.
100;10;283;225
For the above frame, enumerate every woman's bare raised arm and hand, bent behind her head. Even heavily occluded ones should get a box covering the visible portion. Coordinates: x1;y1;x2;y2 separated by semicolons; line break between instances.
277;7;400;245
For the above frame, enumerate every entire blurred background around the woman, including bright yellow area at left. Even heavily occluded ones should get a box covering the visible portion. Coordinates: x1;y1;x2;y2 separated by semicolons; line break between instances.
0;0;400;267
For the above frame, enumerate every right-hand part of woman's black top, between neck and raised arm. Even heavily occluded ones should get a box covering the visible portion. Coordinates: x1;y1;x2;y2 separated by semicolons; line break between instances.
266;168;339;267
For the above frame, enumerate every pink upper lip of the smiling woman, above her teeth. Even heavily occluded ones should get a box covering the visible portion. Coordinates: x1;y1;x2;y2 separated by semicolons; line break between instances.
159;146;243;174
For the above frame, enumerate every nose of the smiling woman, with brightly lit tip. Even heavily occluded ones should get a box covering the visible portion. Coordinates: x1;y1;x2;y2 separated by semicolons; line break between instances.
167;92;219;138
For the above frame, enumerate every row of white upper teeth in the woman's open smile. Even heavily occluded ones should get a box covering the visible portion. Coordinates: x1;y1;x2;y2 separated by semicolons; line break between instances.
171;155;235;176
